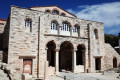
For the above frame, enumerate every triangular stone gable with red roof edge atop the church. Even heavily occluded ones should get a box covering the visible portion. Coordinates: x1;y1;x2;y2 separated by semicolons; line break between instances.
30;6;76;17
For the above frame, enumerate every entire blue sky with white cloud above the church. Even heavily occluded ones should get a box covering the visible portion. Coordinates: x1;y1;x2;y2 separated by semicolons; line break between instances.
0;0;120;35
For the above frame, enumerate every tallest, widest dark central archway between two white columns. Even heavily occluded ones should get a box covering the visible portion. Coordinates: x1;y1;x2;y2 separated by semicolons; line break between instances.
59;41;73;71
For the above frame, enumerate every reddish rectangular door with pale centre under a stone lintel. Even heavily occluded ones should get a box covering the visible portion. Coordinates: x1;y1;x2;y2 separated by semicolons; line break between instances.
23;59;32;74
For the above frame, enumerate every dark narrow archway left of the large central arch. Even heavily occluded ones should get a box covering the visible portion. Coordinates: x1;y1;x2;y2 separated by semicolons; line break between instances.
47;41;56;67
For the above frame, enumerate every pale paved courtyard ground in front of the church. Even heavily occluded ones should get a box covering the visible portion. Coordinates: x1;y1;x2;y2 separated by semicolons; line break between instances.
50;72;120;80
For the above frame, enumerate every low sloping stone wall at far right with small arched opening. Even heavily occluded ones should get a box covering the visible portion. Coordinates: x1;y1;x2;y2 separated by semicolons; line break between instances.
102;44;120;70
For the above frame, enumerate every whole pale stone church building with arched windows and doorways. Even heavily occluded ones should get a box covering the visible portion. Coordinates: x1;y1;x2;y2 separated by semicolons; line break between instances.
0;6;120;80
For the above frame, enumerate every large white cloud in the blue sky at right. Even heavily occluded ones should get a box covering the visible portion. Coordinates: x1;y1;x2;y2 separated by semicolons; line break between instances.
68;2;120;28
